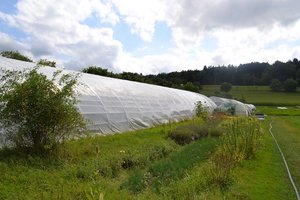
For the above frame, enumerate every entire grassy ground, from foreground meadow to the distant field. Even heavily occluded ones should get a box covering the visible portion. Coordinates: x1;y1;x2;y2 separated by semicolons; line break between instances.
0;86;300;200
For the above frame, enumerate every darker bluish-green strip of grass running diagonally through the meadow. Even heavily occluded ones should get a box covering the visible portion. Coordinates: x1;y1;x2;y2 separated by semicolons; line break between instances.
124;138;217;192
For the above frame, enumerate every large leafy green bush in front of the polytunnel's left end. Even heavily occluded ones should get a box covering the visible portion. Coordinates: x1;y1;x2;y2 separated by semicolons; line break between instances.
0;68;85;154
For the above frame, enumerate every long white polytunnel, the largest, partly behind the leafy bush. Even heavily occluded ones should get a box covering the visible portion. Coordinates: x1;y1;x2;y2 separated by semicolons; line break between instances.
0;56;216;134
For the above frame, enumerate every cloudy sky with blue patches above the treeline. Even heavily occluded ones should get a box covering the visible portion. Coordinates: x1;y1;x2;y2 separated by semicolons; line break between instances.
0;0;300;74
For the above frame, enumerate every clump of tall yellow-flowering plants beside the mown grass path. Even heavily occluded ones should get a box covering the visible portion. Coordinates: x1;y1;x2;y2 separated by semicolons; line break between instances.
208;117;262;188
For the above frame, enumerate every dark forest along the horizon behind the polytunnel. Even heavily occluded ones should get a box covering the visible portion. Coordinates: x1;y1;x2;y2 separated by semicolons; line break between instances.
82;58;300;91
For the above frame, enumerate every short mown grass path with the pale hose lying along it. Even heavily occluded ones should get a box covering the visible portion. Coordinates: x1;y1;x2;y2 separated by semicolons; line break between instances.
223;117;300;200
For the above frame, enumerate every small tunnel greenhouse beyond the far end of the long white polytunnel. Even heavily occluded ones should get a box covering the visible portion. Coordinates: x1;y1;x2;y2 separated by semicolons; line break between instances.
209;96;255;116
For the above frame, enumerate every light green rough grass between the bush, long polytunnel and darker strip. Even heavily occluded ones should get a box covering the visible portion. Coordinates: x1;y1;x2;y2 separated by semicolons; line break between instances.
0;122;180;199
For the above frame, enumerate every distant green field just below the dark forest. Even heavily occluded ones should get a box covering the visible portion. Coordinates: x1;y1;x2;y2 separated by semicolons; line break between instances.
200;85;300;106
